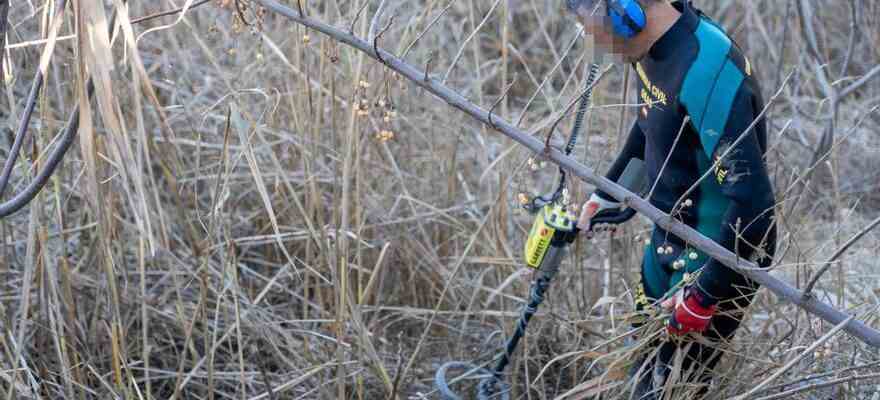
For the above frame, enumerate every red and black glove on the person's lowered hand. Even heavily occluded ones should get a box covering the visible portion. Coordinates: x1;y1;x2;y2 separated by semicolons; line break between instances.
662;286;718;335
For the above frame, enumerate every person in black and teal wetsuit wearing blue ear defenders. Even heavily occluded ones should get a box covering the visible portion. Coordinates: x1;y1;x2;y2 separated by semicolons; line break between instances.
567;0;776;399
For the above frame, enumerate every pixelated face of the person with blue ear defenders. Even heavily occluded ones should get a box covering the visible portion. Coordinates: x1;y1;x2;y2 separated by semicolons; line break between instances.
567;0;634;62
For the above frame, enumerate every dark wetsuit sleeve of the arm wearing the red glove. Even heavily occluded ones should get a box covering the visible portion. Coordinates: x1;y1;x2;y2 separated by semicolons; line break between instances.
697;85;775;300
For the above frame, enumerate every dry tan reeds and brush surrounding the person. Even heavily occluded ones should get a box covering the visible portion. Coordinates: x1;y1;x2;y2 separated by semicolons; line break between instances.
0;0;880;399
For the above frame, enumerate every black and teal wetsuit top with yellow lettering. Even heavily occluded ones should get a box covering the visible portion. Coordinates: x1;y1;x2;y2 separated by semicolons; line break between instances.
598;2;776;299
